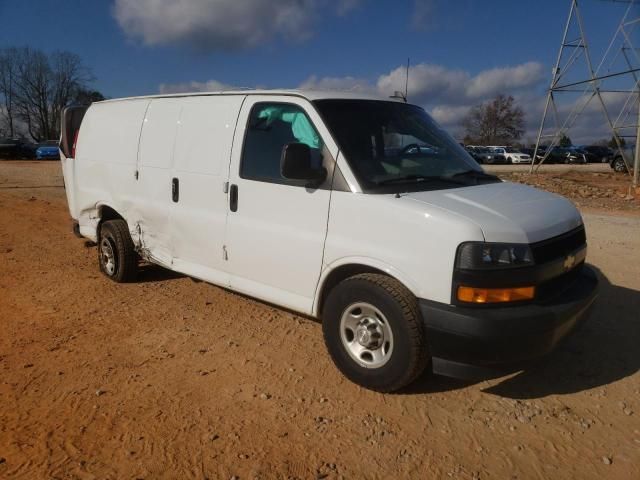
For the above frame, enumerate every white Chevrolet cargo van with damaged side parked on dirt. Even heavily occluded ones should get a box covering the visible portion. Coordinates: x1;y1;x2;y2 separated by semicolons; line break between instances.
61;91;597;391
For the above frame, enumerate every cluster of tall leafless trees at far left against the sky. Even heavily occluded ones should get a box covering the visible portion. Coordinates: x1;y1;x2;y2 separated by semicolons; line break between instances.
0;47;92;142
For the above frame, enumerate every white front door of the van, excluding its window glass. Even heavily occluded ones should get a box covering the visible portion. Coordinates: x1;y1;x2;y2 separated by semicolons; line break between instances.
226;95;337;313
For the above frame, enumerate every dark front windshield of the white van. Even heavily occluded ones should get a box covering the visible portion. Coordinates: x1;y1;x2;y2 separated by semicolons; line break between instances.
314;100;499;193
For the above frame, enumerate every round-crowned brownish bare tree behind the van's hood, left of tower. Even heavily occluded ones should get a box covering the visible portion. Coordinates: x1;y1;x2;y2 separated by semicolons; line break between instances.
462;94;524;145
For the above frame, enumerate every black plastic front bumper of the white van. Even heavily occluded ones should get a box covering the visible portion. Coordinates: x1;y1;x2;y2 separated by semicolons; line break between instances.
420;265;598;373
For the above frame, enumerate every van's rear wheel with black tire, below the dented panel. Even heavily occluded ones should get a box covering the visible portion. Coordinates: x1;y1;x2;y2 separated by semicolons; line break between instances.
98;219;138;283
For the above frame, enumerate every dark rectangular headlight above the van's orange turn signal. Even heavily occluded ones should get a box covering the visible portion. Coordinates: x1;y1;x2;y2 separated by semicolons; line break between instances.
456;242;534;270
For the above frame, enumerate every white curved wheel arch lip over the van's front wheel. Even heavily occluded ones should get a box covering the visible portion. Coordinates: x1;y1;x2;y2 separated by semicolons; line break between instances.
312;257;418;318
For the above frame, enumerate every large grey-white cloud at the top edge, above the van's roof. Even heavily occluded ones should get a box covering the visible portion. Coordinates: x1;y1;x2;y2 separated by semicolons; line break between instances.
114;0;361;50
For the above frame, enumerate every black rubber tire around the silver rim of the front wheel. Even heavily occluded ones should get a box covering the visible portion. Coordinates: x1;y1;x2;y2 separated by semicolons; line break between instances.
322;273;430;392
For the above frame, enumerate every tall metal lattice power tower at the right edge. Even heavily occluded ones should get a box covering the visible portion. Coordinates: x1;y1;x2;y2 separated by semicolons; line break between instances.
530;0;640;186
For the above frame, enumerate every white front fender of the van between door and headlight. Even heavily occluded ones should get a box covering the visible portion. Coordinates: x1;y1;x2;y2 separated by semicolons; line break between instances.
313;192;484;315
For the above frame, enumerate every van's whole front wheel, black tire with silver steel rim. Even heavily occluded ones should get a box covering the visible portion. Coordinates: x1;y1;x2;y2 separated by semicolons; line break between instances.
322;273;430;392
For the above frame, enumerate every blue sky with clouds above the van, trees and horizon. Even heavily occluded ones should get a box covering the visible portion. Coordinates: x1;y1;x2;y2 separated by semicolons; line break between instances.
0;0;636;142
